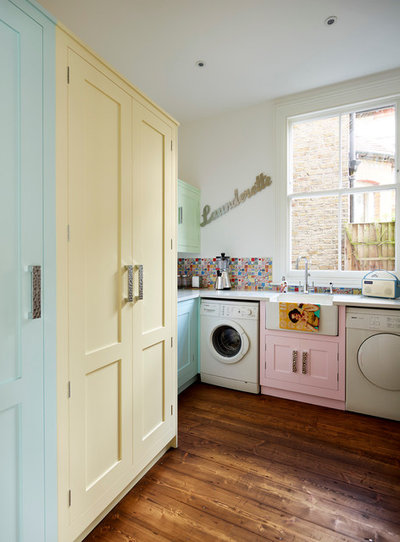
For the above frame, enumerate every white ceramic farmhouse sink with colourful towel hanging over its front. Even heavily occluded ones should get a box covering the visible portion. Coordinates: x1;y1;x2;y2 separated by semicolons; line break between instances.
265;292;338;335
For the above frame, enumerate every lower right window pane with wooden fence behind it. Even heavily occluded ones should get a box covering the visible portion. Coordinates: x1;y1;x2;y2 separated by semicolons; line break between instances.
342;190;396;271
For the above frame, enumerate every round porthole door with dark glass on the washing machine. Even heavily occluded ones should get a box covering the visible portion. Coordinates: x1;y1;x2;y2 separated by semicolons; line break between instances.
209;320;250;364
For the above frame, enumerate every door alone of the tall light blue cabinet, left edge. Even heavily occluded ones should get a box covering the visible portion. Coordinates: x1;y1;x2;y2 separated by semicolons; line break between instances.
0;0;45;542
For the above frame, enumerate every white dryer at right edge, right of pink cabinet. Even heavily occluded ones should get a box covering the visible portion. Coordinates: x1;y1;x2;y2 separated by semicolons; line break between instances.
346;307;400;420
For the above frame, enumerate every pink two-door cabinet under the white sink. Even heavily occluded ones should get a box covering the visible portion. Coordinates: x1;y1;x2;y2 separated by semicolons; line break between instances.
260;301;346;410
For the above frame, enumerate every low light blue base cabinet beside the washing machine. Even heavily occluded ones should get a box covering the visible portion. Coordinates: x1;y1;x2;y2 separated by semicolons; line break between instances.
178;299;199;393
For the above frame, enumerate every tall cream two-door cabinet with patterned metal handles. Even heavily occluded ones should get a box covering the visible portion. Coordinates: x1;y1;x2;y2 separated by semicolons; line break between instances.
56;28;177;542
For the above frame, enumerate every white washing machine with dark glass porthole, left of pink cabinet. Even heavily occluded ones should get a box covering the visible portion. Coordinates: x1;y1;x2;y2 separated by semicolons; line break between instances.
200;299;260;393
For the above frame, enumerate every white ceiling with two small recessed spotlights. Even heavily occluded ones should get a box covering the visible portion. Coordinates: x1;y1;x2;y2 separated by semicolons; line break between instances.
39;0;400;122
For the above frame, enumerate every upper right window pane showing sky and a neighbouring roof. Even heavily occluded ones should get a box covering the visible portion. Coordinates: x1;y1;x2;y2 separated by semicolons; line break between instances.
342;106;396;188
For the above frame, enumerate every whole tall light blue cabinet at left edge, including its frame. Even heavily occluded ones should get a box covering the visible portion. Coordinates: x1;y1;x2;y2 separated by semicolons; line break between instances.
0;0;57;542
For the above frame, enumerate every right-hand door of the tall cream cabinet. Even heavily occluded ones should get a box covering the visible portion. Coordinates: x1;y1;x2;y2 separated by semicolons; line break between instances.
133;103;176;472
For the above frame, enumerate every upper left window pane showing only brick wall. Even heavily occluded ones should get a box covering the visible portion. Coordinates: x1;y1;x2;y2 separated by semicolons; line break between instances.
289;115;340;193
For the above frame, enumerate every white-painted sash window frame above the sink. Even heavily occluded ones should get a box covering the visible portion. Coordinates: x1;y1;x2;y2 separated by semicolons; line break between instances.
273;69;400;288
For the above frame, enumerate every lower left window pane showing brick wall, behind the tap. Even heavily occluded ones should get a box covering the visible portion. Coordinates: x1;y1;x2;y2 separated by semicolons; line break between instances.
291;196;339;270
